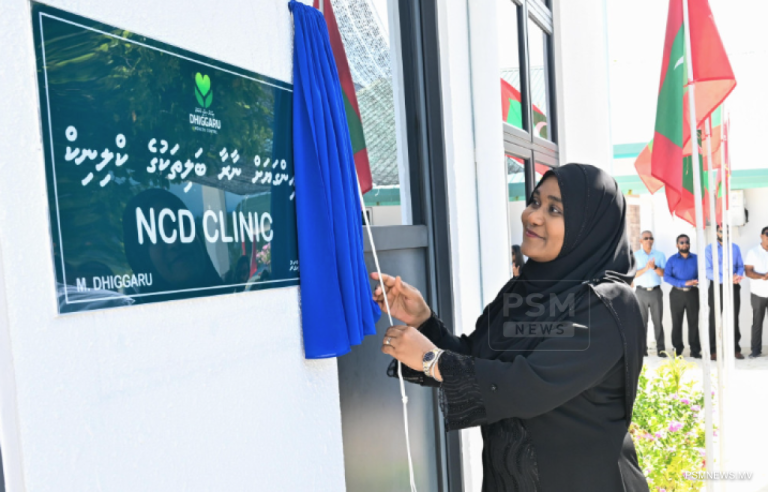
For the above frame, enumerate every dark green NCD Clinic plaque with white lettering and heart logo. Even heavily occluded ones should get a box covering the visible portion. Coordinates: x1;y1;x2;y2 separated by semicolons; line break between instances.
32;2;299;313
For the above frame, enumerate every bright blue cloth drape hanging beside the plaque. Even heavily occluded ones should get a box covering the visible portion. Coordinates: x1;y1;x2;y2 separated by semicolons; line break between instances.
289;0;381;359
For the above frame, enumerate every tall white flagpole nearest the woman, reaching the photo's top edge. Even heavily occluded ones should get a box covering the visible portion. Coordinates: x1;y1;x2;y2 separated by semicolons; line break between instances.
680;0;714;480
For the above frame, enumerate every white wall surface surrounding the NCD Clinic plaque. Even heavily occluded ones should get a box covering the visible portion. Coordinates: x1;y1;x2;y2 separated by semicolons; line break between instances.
0;0;345;492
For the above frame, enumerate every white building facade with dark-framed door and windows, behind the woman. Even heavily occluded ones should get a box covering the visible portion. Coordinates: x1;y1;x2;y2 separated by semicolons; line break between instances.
0;0;612;491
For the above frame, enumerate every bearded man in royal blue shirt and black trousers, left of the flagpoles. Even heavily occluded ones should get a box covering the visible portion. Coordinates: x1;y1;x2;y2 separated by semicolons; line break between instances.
664;234;701;359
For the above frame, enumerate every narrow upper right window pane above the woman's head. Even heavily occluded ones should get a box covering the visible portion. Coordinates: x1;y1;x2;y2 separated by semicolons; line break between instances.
528;19;552;140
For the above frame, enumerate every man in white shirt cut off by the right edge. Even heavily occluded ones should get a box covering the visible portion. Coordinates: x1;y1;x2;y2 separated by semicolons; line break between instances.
744;227;768;359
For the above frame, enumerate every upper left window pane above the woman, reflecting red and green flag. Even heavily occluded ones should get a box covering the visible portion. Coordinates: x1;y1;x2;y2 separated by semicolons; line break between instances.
496;0;525;128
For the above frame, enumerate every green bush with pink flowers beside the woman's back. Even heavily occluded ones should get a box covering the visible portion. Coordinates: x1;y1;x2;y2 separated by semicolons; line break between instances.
630;357;705;492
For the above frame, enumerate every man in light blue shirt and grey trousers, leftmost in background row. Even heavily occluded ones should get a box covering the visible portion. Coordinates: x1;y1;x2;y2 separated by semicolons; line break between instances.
634;231;667;357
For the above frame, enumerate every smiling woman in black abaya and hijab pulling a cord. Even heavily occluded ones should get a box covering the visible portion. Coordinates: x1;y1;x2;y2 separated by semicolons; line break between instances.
372;164;648;492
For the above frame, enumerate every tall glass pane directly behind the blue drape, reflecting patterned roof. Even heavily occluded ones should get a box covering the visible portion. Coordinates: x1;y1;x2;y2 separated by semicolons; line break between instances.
334;0;411;225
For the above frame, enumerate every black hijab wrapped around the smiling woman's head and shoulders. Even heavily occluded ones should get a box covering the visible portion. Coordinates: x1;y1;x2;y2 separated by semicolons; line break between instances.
486;164;635;358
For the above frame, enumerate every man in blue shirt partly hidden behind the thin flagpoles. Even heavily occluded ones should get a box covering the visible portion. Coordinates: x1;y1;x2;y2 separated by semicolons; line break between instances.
704;225;744;360
